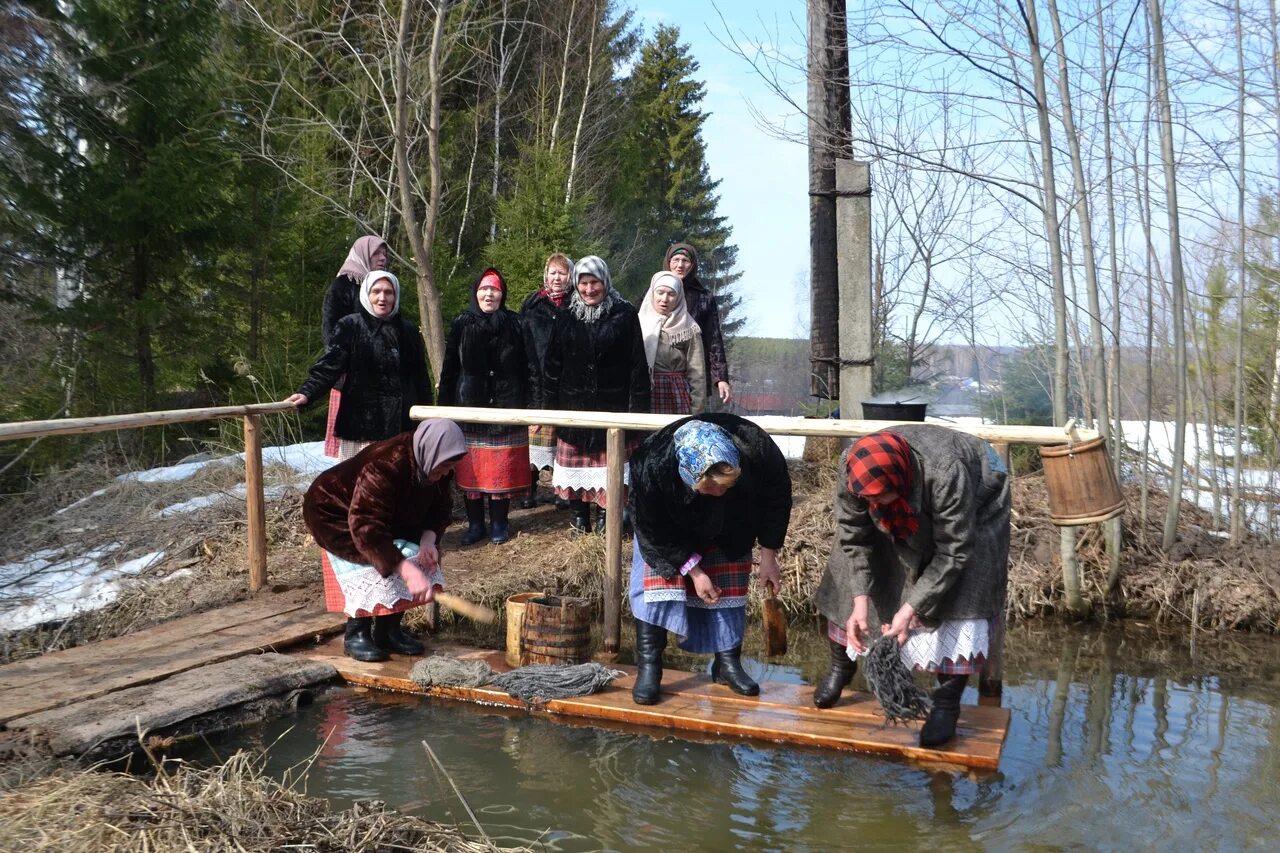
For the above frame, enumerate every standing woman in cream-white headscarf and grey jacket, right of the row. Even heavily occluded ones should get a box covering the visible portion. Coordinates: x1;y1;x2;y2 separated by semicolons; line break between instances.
640;270;707;415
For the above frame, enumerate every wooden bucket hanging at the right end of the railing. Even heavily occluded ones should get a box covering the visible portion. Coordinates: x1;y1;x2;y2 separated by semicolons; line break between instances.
1041;437;1124;526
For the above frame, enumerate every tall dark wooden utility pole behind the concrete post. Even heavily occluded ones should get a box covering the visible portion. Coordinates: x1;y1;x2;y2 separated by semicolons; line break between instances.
808;0;852;400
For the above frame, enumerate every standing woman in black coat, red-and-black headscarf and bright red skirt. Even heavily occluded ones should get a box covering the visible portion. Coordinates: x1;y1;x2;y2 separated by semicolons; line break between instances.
439;268;530;544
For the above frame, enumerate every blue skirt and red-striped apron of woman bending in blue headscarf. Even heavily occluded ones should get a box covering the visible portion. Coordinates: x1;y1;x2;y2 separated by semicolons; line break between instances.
627;540;751;654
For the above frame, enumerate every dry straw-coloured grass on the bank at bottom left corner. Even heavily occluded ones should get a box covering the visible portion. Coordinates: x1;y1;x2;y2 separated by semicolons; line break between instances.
0;752;509;853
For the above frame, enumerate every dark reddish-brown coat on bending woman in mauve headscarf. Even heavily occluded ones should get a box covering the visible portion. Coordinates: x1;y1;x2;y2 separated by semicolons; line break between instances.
302;432;453;578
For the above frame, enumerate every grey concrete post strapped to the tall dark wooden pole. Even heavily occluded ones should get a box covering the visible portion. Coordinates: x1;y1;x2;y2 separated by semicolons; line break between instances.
836;159;873;418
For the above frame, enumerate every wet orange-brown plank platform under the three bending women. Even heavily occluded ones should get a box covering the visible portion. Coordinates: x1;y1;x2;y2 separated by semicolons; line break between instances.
296;638;1010;770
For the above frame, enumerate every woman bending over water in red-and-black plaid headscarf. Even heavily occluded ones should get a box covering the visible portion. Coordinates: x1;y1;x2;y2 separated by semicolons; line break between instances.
813;424;1010;747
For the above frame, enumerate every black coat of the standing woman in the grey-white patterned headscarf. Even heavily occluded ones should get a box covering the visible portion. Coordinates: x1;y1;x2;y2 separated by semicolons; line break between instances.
538;297;649;452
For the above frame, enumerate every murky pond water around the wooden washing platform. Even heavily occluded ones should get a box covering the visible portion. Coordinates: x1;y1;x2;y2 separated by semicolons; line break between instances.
186;622;1280;850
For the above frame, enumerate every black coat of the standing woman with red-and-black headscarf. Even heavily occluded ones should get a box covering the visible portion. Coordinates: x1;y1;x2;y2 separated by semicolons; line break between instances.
439;270;529;409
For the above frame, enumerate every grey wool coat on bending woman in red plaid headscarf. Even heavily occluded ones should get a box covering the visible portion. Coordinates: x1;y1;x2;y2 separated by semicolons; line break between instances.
814;424;1010;635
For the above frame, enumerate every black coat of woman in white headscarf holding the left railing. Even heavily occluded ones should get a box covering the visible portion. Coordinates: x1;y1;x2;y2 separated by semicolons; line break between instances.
298;309;431;442
